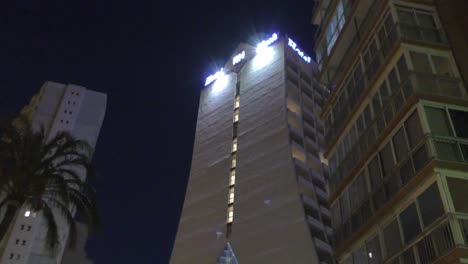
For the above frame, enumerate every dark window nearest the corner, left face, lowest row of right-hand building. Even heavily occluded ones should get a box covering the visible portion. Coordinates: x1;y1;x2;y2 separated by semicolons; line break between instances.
418;183;444;227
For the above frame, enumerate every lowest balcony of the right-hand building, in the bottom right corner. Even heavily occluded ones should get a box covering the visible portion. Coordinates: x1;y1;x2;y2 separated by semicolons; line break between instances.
386;214;468;263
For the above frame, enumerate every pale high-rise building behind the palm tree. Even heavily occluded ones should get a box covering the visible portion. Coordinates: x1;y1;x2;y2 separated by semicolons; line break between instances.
0;82;107;264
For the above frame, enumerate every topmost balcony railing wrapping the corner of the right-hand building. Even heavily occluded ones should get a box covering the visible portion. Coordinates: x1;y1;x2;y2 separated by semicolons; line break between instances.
326;23;446;150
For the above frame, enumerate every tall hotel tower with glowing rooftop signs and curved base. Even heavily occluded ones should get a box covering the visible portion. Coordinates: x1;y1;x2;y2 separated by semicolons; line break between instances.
170;34;332;264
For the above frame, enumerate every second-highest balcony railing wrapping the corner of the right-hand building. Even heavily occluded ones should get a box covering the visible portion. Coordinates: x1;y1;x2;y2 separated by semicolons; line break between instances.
330;72;468;192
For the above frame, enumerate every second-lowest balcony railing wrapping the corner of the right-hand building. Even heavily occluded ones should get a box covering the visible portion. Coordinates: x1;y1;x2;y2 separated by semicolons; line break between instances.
335;134;468;250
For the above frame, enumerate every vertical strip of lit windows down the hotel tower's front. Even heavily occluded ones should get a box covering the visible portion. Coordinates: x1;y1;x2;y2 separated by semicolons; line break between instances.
227;82;240;226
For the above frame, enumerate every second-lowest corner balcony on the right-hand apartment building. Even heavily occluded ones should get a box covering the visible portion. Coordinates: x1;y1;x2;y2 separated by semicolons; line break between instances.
335;134;468;250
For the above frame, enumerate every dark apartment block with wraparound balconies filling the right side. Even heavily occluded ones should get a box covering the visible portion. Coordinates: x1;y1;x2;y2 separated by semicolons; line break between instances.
312;0;468;264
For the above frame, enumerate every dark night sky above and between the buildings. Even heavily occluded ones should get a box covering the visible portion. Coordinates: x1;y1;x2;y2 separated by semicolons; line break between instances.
0;0;313;264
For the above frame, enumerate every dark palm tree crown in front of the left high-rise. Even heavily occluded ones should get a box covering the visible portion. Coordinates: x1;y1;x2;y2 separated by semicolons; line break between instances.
0;117;99;250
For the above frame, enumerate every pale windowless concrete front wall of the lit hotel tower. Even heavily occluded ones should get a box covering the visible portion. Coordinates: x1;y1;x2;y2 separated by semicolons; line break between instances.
170;35;329;264
